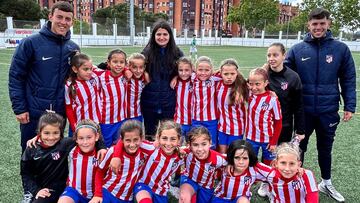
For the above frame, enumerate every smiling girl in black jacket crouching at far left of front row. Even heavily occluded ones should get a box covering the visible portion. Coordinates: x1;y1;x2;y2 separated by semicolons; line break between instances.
20;113;105;202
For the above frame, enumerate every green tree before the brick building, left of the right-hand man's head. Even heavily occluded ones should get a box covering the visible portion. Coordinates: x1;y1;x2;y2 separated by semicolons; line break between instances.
227;0;279;30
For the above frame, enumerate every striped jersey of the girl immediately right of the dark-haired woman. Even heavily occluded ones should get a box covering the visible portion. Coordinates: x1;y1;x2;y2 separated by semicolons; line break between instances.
174;79;193;125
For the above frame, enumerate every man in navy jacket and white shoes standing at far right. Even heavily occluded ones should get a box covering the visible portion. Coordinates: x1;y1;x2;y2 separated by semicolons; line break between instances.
285;8;356;202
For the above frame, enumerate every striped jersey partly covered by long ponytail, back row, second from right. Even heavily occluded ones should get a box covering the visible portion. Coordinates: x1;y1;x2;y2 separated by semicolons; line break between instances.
216;81;246;136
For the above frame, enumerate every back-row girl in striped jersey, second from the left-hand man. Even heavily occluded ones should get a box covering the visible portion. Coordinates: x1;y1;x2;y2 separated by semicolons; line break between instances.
99;49;127;147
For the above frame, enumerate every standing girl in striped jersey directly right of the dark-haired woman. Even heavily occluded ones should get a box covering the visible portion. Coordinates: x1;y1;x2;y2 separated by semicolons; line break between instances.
174;57;193;141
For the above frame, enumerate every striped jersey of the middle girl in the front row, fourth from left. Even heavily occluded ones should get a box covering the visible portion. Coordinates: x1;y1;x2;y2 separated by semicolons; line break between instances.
139;148;184;196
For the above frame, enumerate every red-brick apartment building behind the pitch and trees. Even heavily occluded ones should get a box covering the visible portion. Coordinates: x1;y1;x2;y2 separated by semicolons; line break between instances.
39;0;299;36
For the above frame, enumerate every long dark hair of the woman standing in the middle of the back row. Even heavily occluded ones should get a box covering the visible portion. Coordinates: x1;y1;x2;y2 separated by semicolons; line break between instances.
143;20;181;73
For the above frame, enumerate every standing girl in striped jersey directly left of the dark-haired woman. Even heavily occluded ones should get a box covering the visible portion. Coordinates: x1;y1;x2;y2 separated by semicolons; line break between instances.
126;53;149;122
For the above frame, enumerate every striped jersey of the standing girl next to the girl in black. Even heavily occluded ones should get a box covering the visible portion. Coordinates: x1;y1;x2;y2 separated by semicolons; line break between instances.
246;91;282;143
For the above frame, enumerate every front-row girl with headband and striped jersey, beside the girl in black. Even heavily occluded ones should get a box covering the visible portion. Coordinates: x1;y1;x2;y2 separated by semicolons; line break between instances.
58;119;101;203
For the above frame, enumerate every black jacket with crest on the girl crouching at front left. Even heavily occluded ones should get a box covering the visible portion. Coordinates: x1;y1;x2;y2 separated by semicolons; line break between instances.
20;137;106;197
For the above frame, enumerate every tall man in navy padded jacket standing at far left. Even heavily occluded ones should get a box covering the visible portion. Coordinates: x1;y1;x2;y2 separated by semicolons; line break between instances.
9;2;79;151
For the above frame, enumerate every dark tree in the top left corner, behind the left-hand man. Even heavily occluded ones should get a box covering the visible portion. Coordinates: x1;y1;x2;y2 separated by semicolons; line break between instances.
0;0;40;21
